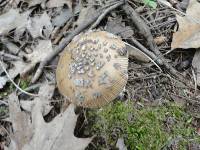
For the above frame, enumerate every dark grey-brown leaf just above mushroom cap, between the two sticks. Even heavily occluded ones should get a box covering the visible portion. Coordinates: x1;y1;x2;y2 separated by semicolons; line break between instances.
105;17;134;39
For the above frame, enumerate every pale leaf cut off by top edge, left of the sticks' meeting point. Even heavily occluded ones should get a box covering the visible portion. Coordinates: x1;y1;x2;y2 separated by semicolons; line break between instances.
46;0;72;9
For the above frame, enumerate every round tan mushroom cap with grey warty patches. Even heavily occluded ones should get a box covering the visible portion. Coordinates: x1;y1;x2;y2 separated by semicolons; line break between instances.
56;31;128;108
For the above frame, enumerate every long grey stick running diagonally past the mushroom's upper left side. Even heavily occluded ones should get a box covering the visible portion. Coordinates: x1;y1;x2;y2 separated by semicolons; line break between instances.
31;0;125;83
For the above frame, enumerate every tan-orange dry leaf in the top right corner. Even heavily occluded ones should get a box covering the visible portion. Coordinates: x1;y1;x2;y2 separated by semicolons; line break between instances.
172;0;200;49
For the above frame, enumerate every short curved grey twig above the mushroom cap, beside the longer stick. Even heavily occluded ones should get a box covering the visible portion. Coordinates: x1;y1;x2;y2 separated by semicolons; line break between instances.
89;1;124;30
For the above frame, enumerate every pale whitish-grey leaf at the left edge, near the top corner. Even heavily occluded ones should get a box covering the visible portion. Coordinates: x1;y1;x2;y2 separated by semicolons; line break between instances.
0;9;29;36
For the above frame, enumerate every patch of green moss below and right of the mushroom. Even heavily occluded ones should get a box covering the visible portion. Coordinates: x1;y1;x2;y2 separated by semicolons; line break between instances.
89;102;200;150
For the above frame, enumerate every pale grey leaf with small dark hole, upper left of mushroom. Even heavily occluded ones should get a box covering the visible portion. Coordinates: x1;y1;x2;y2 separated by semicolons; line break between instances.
27;12;53;38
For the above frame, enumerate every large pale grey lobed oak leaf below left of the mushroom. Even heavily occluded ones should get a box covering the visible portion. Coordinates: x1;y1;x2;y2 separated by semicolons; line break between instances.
5;85;91;150
